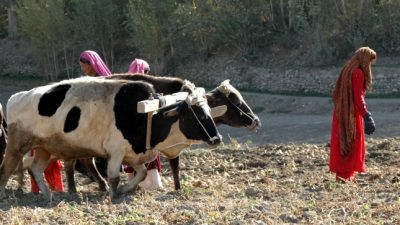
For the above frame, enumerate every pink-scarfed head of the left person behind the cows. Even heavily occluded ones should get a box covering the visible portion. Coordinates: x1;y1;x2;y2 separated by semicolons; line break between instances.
79;50;111;77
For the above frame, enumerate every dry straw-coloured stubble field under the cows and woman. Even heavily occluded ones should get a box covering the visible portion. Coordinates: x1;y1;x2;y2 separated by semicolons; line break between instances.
0;138;400;224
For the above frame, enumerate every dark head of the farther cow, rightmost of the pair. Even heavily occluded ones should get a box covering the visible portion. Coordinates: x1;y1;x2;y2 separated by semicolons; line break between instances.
207;80;261;130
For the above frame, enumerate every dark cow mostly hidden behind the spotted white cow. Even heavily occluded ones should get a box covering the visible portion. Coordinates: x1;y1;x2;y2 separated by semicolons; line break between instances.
66;74;261;190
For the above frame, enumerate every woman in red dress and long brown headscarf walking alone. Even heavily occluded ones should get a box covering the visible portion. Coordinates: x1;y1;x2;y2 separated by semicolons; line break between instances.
329;47;376;182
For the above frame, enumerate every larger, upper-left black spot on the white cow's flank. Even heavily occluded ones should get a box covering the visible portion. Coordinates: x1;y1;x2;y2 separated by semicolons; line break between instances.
38;84;71;117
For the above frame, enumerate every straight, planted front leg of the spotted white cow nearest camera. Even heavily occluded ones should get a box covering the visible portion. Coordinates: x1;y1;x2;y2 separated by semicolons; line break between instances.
107;154;124;199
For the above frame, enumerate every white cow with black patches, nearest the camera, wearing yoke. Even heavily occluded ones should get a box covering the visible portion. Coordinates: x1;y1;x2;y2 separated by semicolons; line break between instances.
0;77;221;199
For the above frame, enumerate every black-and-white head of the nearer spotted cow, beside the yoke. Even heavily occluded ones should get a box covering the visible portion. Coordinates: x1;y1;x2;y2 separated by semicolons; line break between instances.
163;88;222;148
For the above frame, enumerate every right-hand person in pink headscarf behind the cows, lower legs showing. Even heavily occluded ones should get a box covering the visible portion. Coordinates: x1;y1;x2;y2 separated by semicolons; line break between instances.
124;59;163;190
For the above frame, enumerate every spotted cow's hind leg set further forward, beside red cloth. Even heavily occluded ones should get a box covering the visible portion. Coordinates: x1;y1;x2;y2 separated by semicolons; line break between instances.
29;149;52;201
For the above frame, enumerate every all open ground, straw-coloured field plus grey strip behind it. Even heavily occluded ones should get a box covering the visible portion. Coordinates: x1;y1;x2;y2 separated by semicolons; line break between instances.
0;77;400;224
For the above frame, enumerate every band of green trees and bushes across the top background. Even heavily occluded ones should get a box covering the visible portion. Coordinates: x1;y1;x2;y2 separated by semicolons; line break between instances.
6;0;400;78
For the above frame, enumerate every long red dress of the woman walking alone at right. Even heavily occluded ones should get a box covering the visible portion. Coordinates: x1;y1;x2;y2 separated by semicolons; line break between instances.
329;68;367;180
